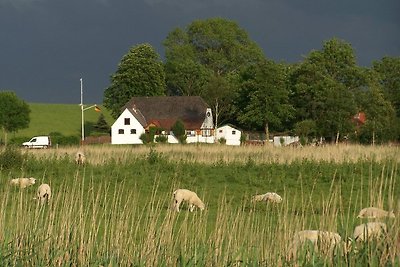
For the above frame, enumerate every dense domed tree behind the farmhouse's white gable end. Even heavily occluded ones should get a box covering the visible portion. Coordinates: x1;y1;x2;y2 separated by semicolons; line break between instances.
104;44;166;118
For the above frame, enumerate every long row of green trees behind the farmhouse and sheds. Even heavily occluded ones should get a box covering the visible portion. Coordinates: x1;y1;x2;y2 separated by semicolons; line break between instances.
104;18;400;146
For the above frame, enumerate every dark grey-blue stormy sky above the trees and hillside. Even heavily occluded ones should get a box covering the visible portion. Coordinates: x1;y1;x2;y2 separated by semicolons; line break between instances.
0;0;400;104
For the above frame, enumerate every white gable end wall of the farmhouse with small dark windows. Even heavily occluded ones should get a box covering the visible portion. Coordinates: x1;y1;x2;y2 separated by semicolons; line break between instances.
111;109;145;144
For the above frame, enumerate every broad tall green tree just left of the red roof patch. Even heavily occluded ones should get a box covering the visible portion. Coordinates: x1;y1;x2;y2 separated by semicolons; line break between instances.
290;38;364;143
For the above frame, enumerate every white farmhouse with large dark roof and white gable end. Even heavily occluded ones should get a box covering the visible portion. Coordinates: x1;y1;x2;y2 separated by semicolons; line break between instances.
111;96;214;144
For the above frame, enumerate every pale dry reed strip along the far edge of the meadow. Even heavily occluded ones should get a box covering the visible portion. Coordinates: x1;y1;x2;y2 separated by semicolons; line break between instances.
18;144;400;165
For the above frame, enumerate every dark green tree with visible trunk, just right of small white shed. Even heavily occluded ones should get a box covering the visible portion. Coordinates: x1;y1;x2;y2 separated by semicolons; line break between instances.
237;60;294;140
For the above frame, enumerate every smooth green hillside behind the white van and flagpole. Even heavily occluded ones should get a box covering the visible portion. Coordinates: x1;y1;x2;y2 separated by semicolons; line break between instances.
10;103;114;138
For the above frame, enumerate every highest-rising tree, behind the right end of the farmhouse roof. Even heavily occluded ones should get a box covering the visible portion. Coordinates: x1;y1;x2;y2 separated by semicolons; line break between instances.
164;18;264;126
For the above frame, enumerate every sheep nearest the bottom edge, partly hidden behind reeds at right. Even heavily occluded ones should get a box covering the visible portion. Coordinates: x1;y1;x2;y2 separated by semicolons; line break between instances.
289;230;344;260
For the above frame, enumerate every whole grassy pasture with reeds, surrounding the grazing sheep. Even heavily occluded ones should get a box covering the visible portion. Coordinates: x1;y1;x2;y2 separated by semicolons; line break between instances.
0;145;400;266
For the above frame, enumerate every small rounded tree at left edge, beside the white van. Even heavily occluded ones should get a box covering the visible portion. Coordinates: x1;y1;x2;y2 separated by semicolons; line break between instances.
0;91;31;144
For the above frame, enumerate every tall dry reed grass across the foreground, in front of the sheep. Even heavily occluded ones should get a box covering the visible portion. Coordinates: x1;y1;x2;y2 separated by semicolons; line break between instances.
0;159;400;266
